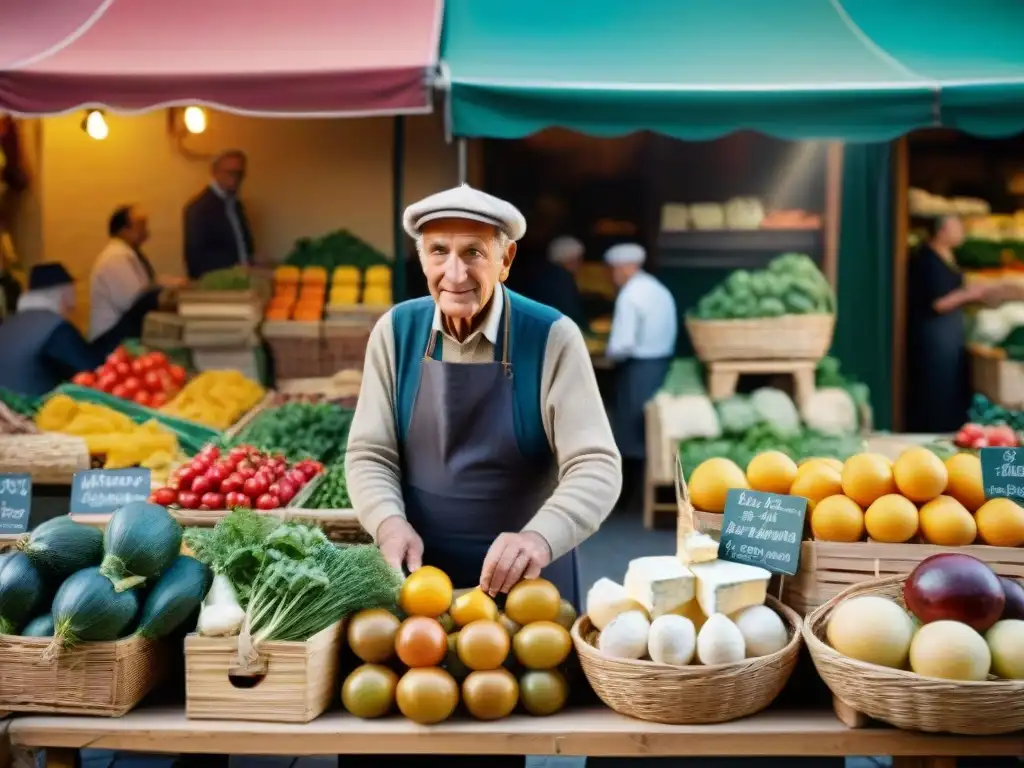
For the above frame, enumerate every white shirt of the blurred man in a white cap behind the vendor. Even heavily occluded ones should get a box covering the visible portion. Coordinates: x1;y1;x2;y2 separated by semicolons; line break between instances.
605;271;679;360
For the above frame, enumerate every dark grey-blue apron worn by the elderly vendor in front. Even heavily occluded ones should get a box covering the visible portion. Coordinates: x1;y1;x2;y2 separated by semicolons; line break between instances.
402;288;581;609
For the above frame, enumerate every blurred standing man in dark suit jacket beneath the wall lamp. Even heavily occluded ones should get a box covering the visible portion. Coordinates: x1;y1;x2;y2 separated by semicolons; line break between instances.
184;150;255;280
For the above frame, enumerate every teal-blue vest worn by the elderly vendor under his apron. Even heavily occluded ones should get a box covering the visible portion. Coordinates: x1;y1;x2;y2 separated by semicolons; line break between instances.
391;291;562;463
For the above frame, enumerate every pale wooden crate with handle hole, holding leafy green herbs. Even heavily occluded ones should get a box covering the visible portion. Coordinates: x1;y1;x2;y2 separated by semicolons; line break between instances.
185;622;345;723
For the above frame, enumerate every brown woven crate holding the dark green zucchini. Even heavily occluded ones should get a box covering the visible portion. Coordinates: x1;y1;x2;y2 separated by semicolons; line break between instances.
0;635;168;717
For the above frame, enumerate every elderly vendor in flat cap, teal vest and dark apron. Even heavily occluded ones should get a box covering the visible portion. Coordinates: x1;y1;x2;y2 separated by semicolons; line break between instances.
346;185;622;606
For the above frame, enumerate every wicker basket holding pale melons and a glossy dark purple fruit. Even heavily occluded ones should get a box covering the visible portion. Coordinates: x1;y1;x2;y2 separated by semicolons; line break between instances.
804;575;1024;736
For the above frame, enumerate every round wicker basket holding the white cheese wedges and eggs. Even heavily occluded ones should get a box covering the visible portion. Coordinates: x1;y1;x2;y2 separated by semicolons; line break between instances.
571;597;801;725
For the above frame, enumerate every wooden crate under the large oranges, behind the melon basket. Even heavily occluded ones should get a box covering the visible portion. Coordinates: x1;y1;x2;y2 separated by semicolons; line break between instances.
782;540;1024;614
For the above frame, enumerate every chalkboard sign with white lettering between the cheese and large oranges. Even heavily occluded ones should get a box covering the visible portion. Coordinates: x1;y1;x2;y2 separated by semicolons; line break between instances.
718;488;807;575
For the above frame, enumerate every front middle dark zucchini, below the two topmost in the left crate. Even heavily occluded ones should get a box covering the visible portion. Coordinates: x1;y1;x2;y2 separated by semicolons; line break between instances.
52;568;138;648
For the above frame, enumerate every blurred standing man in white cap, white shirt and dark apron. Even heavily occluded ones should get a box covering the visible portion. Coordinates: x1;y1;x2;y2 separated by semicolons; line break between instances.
604;243;679;514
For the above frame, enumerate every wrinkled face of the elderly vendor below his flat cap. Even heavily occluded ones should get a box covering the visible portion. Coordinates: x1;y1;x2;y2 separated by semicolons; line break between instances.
420;219;516;323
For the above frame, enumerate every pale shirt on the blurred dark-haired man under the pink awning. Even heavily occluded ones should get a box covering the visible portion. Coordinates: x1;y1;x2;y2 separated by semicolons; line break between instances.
89;238;150;341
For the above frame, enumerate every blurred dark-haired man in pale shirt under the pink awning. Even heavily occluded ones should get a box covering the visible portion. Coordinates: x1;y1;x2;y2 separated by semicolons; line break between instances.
89;206;160;346
